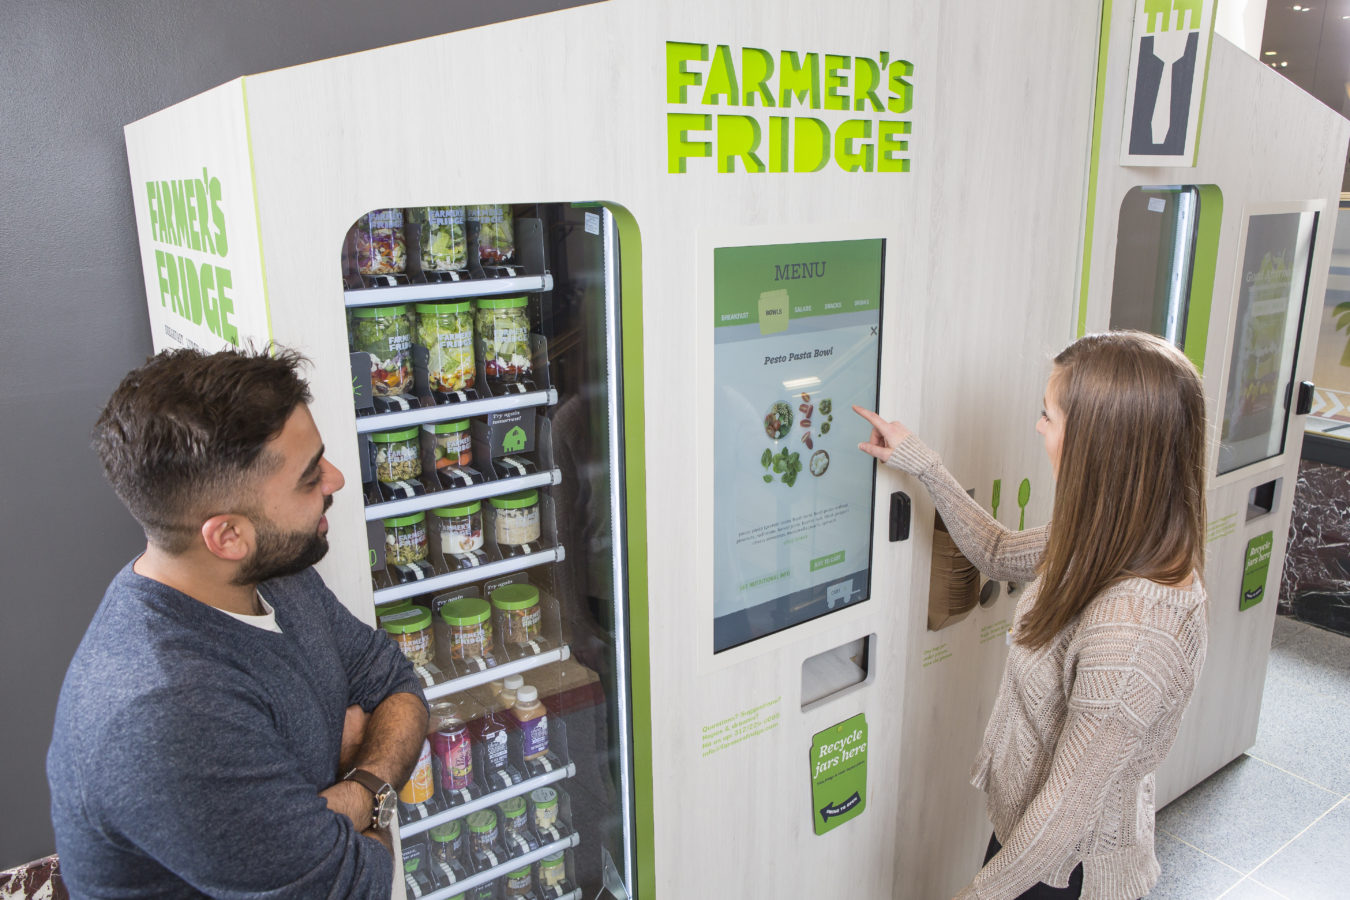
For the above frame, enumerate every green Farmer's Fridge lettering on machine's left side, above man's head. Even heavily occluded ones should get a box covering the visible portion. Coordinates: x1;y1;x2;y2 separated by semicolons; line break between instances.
146;169;239;345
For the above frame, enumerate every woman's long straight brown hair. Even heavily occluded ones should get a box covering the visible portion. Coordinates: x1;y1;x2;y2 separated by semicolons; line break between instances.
1017;332;1206;648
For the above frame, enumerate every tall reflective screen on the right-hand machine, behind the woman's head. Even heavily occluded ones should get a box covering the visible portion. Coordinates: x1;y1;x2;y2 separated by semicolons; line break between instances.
1218;210;1318;475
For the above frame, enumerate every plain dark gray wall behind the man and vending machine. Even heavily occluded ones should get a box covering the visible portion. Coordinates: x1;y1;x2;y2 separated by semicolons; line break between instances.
0;0;586;869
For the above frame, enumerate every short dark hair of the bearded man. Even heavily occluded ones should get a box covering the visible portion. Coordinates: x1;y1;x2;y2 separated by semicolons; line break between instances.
93;345;311;553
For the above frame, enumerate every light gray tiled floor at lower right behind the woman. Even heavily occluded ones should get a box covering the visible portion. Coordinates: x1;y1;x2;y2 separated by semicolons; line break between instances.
1149;617;1350;900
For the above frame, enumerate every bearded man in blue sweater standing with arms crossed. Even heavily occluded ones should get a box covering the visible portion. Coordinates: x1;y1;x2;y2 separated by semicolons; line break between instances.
47;342;427;899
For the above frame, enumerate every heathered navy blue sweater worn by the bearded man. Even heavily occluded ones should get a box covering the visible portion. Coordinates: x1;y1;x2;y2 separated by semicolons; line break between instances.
47;564;421;900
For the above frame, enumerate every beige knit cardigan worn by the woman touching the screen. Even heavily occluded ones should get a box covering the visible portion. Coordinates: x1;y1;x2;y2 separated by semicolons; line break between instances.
887;434;1207;900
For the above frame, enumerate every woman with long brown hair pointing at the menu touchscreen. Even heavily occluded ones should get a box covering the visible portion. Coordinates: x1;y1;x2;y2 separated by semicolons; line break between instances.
853;332;1206;900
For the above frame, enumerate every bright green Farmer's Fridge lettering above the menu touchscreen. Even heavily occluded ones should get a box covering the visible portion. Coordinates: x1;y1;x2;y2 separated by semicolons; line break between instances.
666;40;914;174
